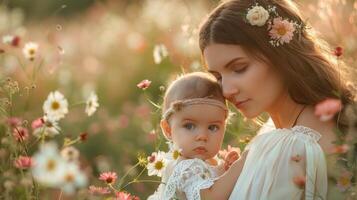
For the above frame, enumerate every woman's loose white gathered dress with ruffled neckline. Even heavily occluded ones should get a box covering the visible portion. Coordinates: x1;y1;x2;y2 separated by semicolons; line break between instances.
229;120;328;200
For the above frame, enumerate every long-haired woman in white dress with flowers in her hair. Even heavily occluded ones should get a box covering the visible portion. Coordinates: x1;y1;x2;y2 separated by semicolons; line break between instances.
199;0;353;199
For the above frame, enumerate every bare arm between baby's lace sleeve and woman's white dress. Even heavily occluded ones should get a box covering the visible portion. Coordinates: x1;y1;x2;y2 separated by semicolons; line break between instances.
200;152;248;200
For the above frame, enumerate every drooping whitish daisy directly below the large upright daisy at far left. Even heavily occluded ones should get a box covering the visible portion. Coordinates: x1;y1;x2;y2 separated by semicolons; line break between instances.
32;116;61;137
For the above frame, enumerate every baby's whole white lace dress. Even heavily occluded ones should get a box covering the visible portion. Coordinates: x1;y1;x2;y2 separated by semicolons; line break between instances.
148;158;223;200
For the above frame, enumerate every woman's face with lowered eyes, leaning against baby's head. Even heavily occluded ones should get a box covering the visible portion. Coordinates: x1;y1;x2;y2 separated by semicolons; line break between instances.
203;44;284;118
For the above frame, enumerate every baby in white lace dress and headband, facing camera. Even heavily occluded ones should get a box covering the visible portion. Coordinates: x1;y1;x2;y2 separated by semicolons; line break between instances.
148;72;242;200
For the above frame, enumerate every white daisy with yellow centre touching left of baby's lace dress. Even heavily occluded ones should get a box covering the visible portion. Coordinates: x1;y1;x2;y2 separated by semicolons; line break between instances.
147;151;167;177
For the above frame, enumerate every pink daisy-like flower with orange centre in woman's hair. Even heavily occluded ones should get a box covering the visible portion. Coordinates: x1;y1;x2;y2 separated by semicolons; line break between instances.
269;17;295;45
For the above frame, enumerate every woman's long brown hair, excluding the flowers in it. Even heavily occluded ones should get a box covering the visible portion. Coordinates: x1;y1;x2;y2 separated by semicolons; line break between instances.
199;0;354;131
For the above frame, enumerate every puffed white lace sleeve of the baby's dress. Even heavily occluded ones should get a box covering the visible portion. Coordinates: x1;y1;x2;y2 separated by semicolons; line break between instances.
163;159;217;200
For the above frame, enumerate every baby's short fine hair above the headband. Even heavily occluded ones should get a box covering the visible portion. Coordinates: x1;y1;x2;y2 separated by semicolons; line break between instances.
162;72;225;113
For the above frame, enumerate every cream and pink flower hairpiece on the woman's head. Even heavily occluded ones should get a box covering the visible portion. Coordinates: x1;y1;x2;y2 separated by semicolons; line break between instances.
245;3;305;47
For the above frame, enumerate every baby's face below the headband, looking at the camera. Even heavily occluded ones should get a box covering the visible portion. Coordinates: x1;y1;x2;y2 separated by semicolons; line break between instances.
170;104;226;160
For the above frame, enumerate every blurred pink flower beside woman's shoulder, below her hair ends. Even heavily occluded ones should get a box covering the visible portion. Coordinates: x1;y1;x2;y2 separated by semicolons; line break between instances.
315;99;342;121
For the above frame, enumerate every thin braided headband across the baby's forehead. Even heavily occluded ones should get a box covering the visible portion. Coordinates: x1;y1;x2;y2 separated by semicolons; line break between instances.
162;98;228;120
